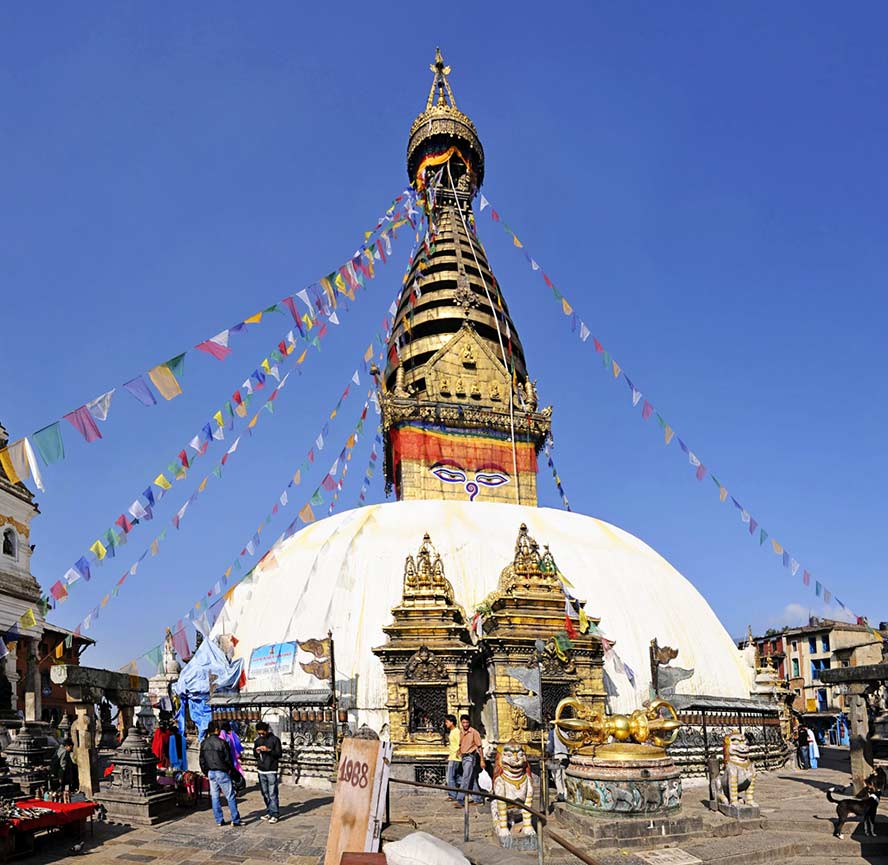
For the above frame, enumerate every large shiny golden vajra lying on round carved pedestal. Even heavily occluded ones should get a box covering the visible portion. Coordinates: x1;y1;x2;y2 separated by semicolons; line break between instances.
553;697;681;751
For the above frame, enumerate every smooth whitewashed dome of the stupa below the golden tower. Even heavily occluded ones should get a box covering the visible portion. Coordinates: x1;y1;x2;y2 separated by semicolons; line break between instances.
212;501;752;730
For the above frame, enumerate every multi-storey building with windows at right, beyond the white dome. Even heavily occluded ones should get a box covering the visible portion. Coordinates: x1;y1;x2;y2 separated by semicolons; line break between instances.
753;616;888;714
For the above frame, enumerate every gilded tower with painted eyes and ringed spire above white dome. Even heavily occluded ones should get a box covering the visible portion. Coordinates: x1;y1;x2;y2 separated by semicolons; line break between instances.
382;51;552;505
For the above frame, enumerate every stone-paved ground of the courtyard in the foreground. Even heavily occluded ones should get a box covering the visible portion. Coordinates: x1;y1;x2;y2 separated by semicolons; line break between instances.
19;749;888;865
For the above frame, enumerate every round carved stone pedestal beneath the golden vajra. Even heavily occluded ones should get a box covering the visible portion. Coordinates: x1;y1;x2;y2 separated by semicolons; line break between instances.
564;745;681;818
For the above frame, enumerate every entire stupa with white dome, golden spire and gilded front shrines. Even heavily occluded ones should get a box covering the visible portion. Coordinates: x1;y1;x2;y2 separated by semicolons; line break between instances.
211;52;776;781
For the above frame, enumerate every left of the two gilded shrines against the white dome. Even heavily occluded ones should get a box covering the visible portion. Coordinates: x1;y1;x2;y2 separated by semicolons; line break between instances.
373;534;475;780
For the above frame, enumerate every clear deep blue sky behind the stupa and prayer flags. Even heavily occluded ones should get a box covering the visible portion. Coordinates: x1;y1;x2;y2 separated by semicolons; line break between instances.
0;3;888;666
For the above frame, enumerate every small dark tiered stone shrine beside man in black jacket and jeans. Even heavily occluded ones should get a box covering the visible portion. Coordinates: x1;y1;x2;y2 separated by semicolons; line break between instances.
94;727;176;826
